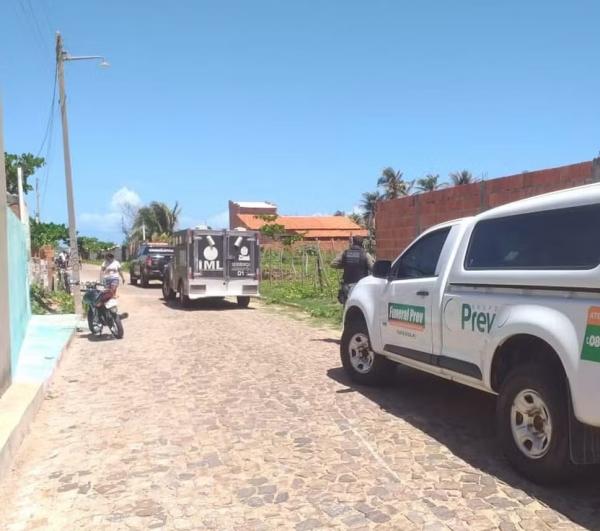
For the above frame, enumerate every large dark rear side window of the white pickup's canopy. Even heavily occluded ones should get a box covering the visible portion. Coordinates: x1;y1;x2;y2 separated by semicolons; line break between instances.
465;205;600;269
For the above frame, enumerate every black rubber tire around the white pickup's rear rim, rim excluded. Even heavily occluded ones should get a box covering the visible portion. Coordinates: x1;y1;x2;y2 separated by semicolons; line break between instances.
496;363;574;484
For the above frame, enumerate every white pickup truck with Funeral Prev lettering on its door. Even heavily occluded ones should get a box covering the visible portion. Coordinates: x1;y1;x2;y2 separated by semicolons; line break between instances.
341;184;600;483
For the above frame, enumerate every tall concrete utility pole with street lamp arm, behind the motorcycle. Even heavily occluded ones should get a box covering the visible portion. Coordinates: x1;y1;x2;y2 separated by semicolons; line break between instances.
56;32;108;317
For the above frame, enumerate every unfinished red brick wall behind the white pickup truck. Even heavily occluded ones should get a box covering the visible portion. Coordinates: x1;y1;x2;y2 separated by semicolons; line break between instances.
375;159;600;260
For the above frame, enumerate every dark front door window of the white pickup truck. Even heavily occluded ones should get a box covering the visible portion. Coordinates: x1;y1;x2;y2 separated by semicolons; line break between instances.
391;227;450;280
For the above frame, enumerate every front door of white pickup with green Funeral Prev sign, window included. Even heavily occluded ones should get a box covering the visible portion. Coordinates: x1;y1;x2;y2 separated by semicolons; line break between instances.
380;227;451;366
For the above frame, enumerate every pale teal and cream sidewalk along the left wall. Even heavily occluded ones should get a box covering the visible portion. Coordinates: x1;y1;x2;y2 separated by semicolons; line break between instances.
0;314;77;477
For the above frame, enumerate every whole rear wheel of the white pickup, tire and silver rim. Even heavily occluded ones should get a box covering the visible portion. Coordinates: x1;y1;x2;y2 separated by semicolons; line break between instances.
496;364;573;484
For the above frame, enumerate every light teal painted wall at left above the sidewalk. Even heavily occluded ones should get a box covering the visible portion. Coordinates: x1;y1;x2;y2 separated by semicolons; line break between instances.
7;209;31;374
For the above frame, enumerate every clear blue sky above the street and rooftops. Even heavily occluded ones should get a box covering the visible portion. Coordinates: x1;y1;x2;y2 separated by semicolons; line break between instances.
0;0;600;240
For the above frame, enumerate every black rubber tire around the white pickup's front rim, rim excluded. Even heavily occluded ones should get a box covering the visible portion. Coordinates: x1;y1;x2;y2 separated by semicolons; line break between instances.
340;319;396;385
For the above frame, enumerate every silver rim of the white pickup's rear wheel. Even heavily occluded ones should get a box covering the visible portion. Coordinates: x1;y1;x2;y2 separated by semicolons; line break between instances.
510;389;552;459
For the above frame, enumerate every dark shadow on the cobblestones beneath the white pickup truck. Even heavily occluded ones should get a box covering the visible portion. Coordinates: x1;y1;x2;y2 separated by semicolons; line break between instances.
327;367;600;529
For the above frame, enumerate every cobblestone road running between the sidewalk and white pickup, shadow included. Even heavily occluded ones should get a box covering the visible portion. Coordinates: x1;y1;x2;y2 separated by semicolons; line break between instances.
0;270;600;531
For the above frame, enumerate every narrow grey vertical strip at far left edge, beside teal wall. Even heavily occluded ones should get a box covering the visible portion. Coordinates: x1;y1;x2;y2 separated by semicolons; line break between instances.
0;101;10;395
